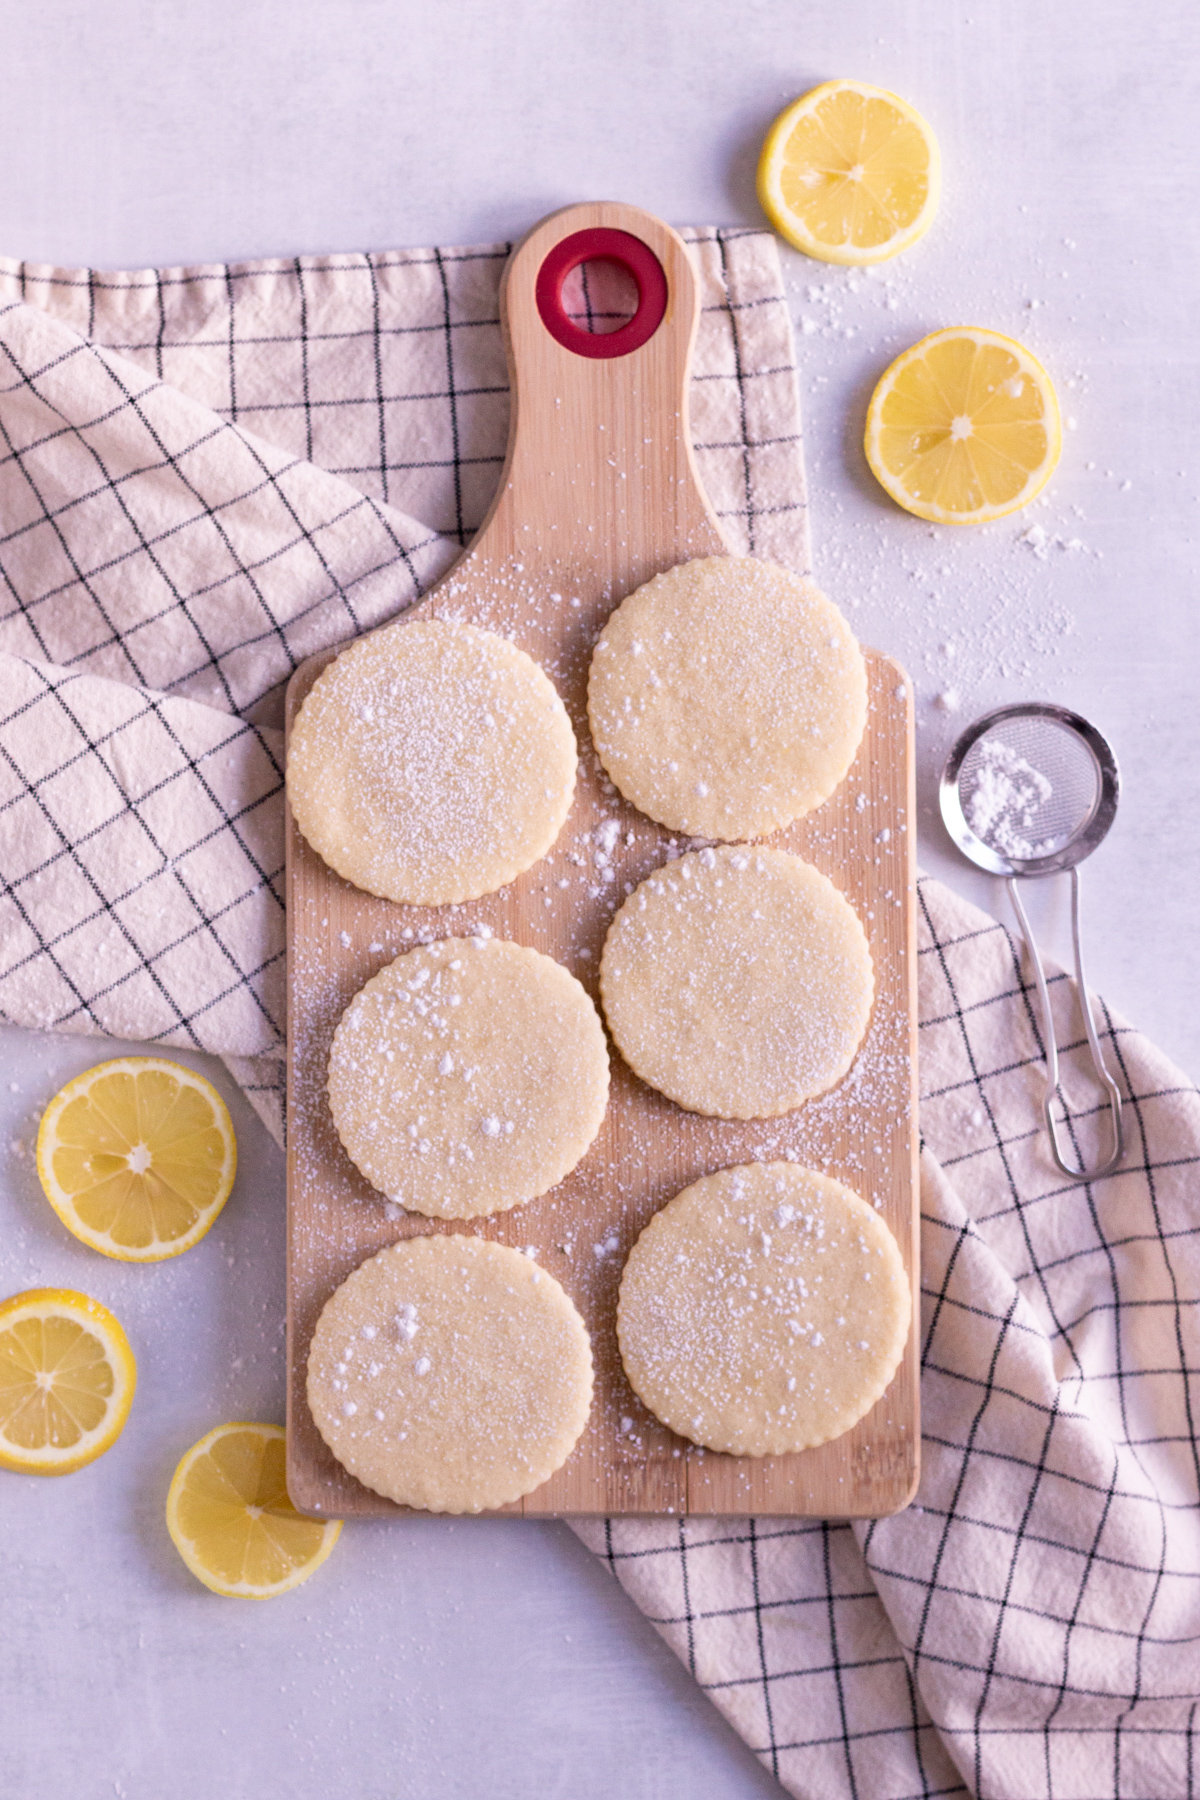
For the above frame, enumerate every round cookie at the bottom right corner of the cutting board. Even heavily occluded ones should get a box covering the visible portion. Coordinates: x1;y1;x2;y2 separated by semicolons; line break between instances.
617;1163;912;1456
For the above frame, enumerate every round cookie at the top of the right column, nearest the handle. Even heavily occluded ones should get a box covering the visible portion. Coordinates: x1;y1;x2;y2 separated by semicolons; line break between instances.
588;556;867;839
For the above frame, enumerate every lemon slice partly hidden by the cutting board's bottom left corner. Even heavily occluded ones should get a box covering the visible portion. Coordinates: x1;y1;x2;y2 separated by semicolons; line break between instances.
167;1424;342;1600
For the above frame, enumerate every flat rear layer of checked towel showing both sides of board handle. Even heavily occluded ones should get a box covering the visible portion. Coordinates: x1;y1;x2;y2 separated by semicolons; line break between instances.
0;229;808;571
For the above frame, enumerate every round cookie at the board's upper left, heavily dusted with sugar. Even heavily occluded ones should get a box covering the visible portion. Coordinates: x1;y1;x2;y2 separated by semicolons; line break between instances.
288;619;576;905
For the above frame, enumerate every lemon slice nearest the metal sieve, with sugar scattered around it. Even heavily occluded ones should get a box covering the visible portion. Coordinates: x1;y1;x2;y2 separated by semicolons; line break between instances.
864;326;1063;526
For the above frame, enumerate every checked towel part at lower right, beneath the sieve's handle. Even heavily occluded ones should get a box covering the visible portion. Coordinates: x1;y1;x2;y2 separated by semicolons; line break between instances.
579;882;1200;1800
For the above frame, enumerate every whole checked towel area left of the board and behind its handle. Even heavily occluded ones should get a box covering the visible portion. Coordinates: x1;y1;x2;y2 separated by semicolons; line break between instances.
0;230;808;1136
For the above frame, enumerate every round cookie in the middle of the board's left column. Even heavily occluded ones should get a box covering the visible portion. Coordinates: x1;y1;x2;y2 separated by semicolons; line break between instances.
329;938;608;1219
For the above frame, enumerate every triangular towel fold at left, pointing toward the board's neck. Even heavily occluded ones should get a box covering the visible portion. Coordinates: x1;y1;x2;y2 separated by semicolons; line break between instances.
0;304;459;724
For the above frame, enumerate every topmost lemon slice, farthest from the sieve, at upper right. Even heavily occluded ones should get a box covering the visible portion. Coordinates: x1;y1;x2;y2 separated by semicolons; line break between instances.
757;81;941;265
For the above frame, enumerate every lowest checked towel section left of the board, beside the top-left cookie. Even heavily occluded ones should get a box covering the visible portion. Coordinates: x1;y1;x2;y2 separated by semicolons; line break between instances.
0;655;284;1055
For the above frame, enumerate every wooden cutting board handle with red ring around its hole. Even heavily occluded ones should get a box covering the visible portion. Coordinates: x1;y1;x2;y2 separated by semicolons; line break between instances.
455;202;730;583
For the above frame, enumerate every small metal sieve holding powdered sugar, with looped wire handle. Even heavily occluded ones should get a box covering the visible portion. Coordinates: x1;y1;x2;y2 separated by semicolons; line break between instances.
939;702;1123;1181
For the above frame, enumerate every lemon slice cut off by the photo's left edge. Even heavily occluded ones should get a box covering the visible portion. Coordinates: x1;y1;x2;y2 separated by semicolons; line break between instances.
0;1287;137;1474
